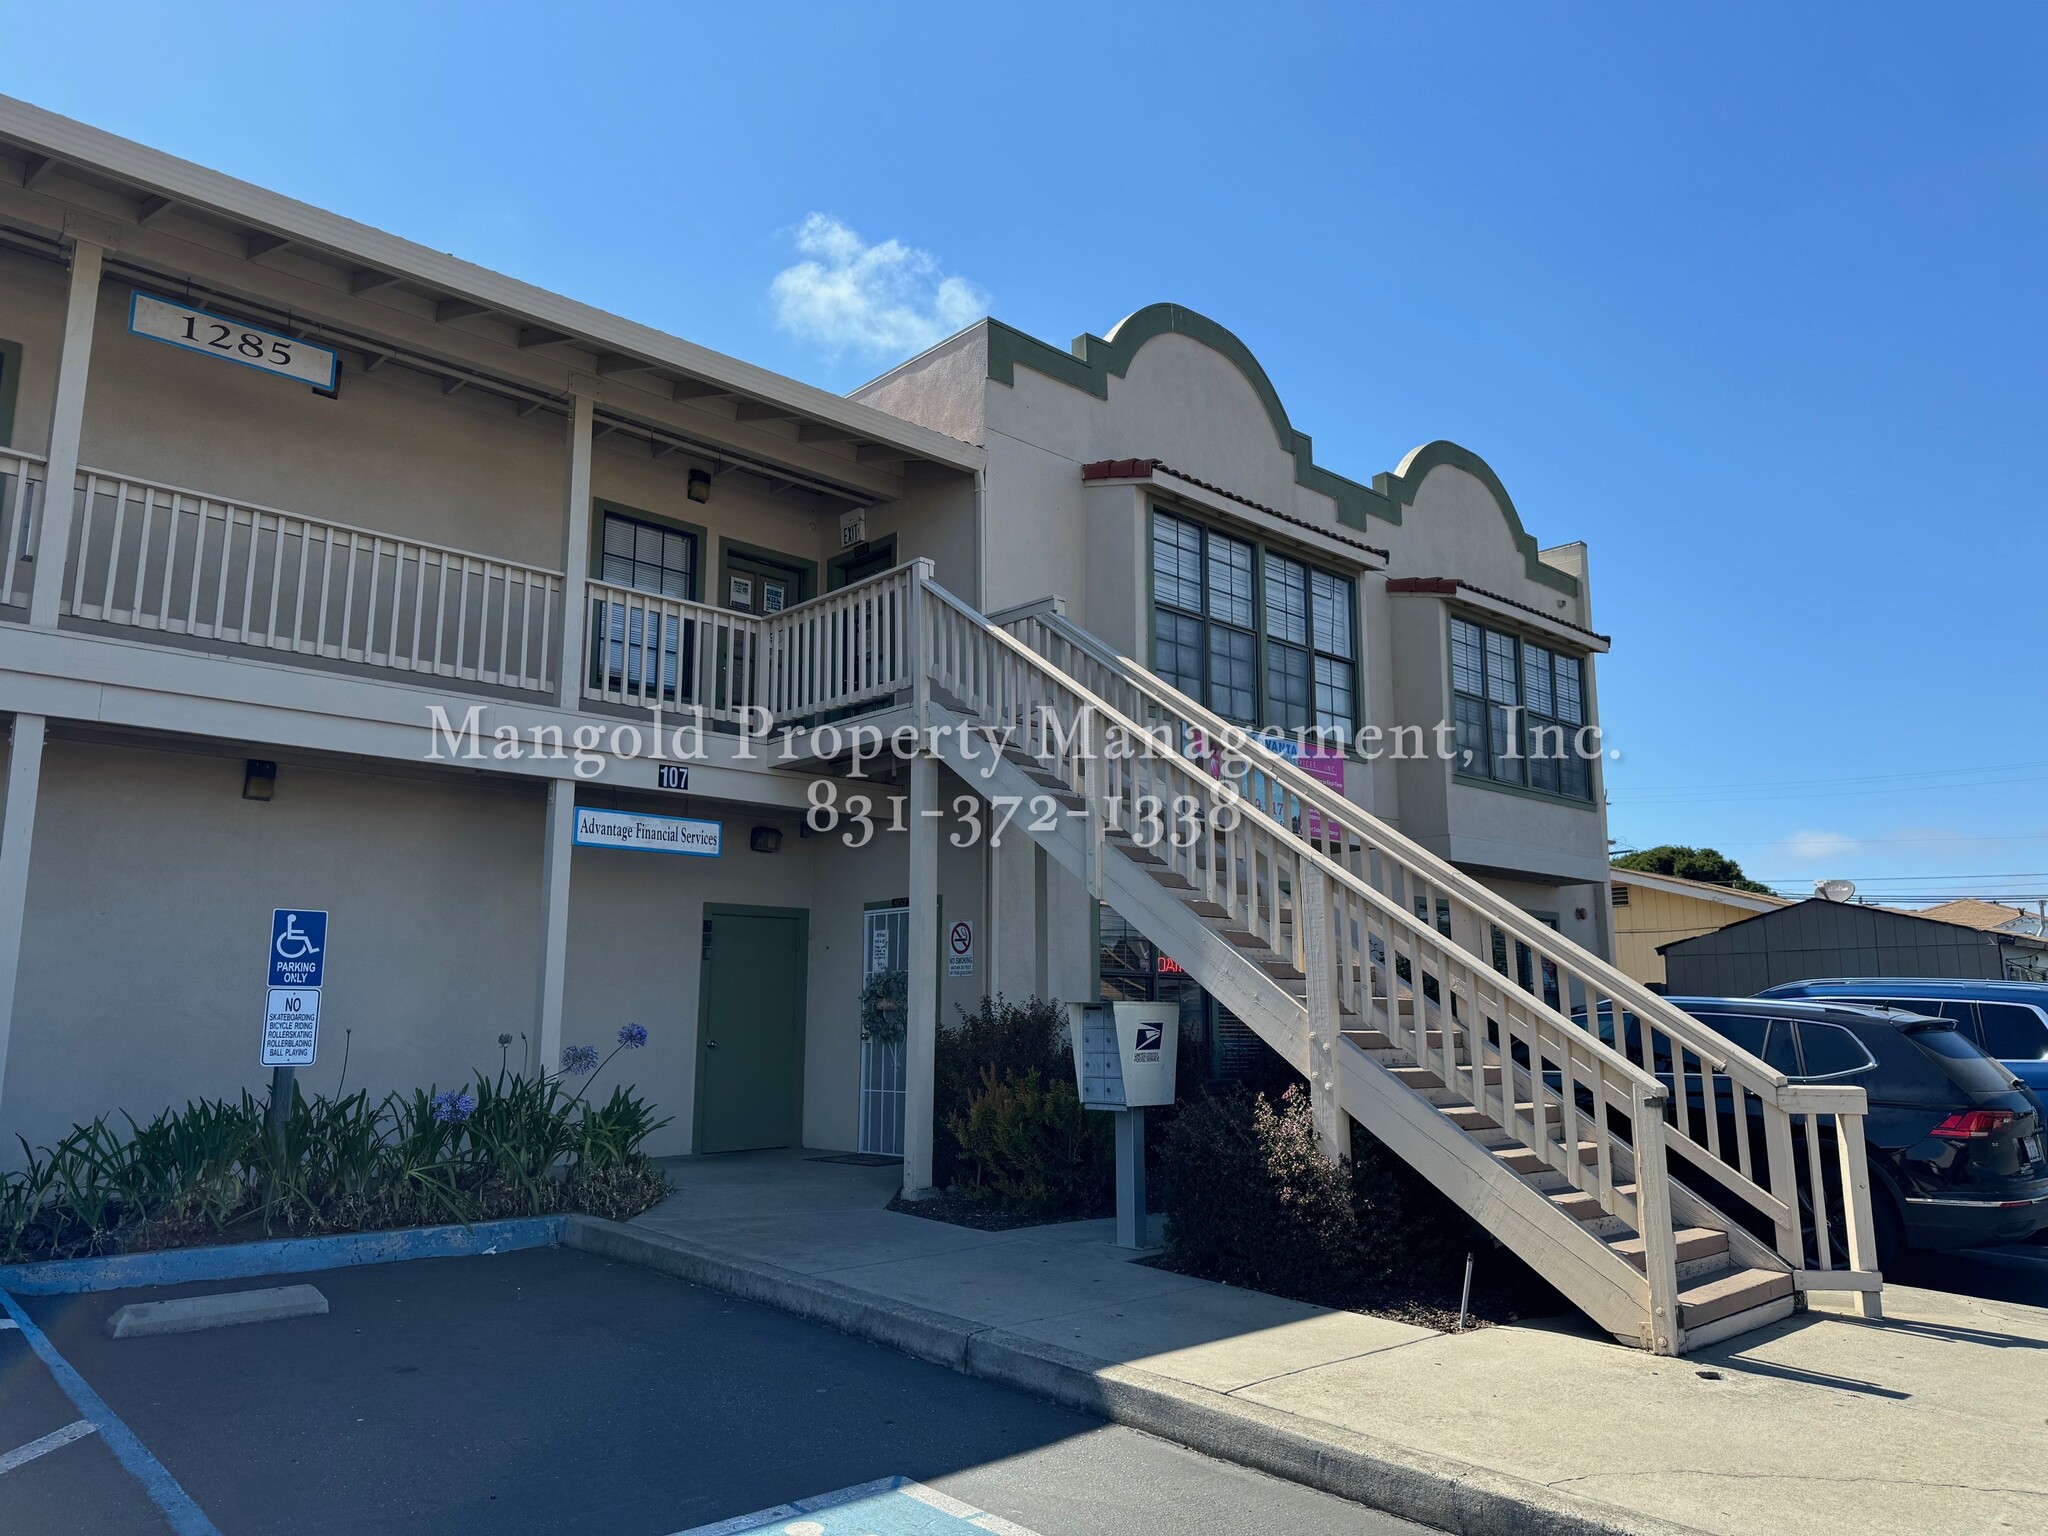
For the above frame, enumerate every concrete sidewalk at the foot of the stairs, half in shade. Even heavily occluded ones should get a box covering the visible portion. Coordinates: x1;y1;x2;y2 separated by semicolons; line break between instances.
567;1153;2048;1536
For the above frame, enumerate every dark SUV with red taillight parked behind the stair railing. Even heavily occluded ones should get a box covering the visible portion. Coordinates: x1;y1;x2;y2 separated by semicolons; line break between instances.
1599;997;2048;1268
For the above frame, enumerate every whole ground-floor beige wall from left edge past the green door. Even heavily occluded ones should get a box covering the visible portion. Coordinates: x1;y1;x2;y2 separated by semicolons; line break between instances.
0;727;995;1165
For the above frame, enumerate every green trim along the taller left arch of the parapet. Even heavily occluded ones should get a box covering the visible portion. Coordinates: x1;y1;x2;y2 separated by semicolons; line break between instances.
987;303;1401;528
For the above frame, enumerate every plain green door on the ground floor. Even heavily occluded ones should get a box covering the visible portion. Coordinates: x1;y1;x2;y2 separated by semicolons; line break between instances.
696;907;809;1153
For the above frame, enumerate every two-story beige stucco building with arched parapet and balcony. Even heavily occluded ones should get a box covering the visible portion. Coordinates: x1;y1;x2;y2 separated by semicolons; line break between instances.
0;100;1610;1186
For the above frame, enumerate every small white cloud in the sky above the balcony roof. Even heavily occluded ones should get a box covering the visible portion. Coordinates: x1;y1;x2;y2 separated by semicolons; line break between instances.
768;213;989;356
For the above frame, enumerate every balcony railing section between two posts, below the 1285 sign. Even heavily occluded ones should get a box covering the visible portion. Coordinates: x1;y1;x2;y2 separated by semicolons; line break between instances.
59;461;561;692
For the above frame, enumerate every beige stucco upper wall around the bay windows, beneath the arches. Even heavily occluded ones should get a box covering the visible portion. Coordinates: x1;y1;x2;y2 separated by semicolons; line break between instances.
862;313;1608;933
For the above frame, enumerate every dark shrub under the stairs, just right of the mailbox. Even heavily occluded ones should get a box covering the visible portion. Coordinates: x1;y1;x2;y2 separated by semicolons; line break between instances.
1161;1087;1360;1300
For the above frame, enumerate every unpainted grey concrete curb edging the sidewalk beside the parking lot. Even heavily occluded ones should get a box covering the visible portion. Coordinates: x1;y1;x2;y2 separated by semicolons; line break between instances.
561;1217;1700;1536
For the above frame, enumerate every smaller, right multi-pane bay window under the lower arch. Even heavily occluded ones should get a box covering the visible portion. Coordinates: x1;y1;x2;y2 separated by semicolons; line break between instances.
1450;618;1593;801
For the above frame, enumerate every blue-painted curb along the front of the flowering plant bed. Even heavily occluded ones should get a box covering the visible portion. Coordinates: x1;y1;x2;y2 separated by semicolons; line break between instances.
0;1217;563;1296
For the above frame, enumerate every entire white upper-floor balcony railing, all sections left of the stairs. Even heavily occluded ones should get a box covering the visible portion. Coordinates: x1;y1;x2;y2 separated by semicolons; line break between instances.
29;462;918;727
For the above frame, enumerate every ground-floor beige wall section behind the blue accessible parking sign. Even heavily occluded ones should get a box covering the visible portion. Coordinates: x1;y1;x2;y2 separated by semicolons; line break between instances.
0;735;543;1155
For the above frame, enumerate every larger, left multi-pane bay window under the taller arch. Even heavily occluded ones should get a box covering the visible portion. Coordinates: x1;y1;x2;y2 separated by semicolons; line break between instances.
1153;512;1358;741
